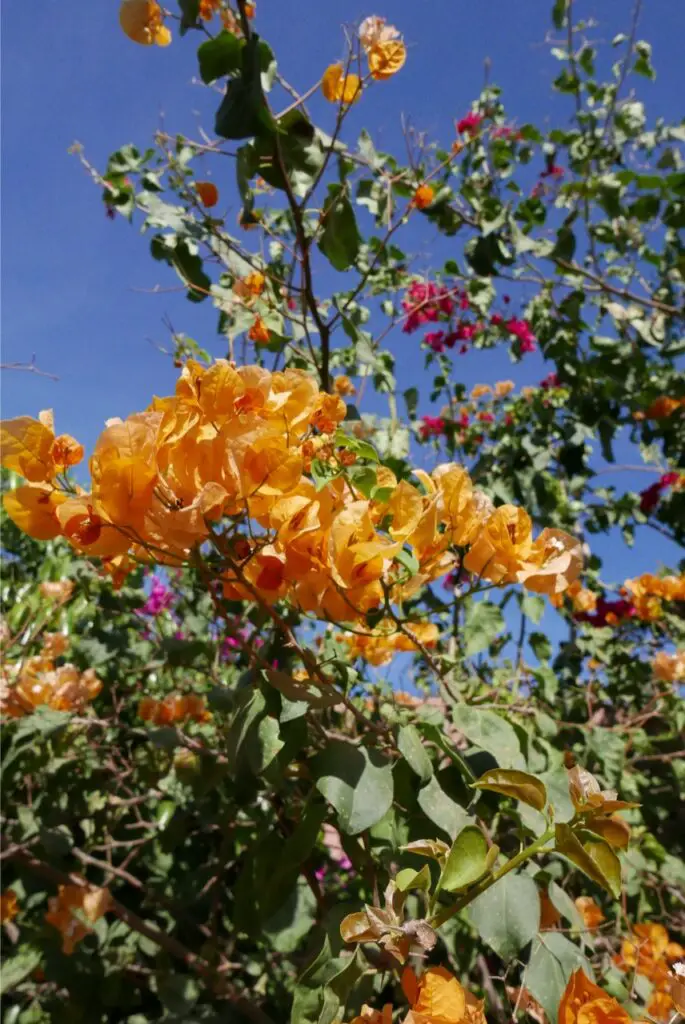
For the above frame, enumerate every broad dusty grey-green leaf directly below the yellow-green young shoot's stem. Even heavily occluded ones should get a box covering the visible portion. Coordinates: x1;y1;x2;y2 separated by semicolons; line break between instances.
468;872;540;961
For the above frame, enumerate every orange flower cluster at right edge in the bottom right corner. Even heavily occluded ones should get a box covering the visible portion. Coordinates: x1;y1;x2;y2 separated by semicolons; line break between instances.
613;922;685;1021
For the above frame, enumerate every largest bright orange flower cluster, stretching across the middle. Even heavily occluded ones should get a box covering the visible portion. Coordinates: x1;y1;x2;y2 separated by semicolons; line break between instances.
2;359;581;622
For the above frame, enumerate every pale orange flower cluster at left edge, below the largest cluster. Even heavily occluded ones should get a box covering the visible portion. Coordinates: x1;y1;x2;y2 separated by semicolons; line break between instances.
0;655;102;718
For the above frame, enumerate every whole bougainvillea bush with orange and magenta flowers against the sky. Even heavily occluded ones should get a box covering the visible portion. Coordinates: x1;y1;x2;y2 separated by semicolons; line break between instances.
0;0;685;1024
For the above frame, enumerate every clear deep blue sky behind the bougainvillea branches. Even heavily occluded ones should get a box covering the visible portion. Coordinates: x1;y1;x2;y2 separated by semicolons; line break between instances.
2;0;685;598
